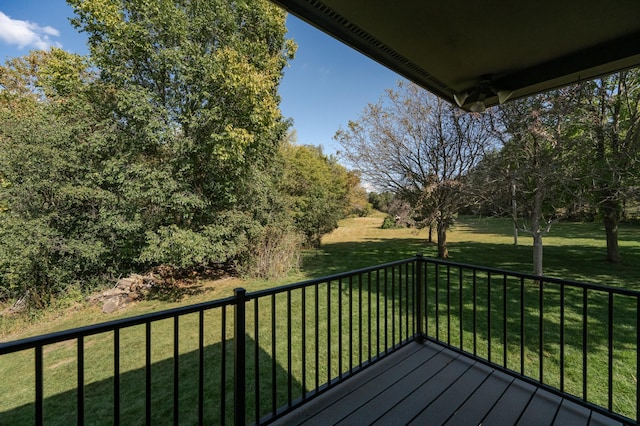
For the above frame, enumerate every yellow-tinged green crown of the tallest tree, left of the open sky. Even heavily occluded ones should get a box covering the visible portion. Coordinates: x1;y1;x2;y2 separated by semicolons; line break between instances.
71;0;294;226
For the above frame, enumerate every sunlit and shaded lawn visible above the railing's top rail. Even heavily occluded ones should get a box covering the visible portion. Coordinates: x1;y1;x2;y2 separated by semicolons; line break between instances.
5;213;640;341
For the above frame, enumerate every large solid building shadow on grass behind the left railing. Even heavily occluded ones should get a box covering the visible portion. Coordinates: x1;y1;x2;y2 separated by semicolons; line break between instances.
0;336;302;425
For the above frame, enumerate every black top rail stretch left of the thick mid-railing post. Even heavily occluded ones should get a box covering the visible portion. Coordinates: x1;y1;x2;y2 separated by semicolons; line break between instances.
0;297;236;355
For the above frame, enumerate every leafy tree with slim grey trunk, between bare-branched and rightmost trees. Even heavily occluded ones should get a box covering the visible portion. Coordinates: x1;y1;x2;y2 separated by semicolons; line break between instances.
490;88;575;275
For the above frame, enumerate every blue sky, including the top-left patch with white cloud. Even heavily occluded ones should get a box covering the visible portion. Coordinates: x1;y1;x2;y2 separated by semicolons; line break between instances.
0;0;401;154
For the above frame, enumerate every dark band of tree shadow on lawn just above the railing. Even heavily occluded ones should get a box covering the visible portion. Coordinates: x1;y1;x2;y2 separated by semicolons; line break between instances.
302;231;640;290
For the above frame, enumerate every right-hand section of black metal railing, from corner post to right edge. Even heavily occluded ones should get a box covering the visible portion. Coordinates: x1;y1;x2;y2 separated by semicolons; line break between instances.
420;259;640;424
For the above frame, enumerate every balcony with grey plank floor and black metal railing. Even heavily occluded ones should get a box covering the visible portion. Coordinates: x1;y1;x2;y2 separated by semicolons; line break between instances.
0;256;640;425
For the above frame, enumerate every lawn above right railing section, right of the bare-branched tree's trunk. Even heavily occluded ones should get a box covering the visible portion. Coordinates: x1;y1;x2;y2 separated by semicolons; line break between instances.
449;217;640;290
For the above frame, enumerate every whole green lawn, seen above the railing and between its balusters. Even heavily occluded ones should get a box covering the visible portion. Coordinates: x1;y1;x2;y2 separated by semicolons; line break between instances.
0;214;640;424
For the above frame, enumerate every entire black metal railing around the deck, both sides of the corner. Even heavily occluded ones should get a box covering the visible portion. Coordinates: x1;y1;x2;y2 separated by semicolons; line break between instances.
0;256;640;424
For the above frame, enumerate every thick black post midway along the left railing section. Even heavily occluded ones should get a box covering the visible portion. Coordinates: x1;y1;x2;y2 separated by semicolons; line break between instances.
234;288;247;425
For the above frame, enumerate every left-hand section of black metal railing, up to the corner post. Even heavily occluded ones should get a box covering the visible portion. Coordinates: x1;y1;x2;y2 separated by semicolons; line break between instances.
0;259;417;424
